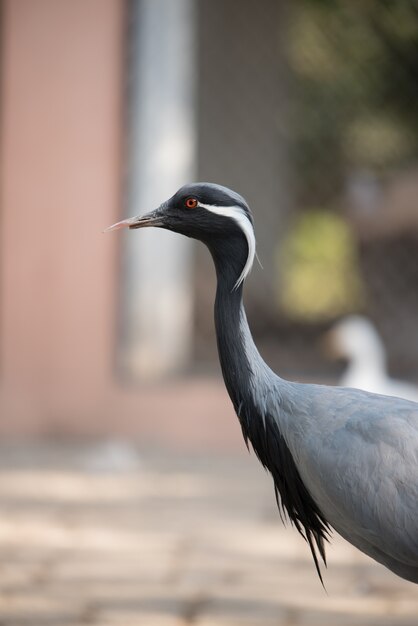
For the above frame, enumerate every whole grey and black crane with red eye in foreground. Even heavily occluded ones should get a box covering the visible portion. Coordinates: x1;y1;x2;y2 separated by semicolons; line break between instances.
107;183;418;583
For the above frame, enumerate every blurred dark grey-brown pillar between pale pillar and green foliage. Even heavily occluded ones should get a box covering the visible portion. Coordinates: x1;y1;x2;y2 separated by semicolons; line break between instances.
196;0;292;330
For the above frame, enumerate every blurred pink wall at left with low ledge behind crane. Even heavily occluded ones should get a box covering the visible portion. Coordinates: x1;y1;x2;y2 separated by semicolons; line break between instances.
0;0;241;445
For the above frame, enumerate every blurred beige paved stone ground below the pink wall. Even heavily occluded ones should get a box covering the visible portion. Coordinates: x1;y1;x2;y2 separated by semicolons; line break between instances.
0;442;418;626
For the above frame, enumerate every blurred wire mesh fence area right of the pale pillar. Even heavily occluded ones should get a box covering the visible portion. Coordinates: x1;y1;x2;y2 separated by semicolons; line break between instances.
195;0;418;379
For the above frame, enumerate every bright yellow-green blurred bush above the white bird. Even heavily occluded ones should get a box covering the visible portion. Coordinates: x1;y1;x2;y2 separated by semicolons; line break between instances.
277;210;362;322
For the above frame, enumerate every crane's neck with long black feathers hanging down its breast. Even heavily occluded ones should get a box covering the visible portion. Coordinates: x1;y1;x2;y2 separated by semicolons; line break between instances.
211;238;329;582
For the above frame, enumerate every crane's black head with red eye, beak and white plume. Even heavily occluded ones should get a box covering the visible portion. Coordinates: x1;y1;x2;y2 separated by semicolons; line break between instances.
106;183;255;287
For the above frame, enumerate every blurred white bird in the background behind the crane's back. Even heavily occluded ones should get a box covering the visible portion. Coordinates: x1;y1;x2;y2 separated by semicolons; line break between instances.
330;315;418;402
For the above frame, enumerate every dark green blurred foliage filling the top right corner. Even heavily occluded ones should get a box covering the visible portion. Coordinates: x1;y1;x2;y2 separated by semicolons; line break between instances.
287;0;418;207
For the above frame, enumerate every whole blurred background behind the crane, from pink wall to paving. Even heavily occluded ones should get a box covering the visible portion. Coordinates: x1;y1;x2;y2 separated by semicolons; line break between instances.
0;0;418;626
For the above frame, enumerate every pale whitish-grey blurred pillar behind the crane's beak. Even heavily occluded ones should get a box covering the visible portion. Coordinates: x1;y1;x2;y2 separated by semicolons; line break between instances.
119;0;196;380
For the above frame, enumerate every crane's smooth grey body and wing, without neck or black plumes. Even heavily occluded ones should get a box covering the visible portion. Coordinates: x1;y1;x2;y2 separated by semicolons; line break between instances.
275;385;418;582
